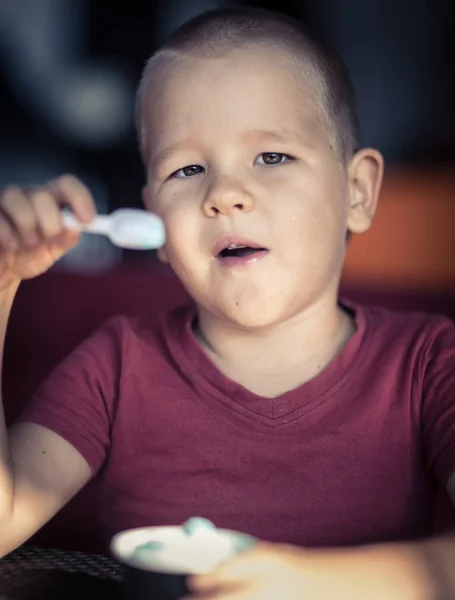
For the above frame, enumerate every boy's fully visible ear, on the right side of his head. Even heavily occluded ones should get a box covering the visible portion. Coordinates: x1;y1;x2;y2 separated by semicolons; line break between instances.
347;148;384;233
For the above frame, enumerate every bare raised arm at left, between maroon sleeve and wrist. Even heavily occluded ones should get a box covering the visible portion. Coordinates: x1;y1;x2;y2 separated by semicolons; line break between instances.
0;284;91;556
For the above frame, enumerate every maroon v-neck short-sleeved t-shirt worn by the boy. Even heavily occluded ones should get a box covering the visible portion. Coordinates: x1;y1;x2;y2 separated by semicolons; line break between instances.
22;305;455;546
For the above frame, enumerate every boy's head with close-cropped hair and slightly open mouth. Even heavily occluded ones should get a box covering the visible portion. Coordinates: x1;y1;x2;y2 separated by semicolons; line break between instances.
138;8;382;328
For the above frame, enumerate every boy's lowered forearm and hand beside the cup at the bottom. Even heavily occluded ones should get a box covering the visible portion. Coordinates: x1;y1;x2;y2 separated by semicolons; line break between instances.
187;543;424;600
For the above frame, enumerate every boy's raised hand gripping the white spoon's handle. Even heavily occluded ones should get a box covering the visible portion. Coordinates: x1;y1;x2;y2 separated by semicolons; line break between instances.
0;175;95;291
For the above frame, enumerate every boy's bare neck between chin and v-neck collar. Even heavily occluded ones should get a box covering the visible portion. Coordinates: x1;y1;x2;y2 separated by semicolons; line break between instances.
195;300;355;397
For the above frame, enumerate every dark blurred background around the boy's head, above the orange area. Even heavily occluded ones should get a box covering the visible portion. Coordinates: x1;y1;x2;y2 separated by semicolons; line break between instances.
0;0;455;269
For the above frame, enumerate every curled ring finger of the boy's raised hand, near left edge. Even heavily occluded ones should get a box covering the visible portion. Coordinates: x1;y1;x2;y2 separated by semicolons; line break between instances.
0;187;38;246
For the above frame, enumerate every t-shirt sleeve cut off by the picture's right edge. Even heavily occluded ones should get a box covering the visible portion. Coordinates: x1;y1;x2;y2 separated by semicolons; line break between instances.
422;318;455;487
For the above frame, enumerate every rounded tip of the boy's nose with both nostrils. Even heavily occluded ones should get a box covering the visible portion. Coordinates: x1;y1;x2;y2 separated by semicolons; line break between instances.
202;180;254;217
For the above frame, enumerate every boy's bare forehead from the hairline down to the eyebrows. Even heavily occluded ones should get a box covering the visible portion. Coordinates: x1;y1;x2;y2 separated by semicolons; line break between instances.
137;47;333;164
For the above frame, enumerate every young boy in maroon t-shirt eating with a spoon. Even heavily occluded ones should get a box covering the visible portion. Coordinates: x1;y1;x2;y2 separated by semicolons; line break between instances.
0;9;455;600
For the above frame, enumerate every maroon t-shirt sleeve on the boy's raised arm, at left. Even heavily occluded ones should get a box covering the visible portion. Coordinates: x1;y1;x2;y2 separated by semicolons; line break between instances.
19;318;126;475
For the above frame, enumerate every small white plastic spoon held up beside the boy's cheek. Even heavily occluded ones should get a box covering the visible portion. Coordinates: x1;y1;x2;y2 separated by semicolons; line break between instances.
62;208;166;250
